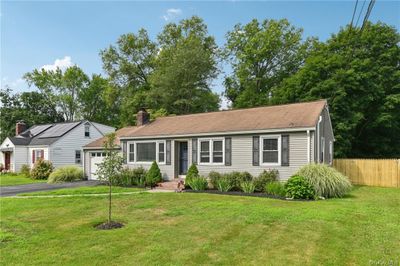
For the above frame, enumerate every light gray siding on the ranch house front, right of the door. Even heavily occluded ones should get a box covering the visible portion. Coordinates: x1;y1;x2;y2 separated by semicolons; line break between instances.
189;132;308;180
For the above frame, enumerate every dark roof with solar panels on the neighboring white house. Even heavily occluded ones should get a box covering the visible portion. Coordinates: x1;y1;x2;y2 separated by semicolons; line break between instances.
10;120;87;145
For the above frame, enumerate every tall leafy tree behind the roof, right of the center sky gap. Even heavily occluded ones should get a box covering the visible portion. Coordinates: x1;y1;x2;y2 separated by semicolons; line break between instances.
224;19;311;108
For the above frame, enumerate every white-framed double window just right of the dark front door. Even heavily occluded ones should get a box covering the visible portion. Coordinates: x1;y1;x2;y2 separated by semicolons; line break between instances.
199;139;224;164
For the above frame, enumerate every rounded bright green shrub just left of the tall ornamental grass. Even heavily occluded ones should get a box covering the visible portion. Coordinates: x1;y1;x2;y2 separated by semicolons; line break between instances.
285;175;315;199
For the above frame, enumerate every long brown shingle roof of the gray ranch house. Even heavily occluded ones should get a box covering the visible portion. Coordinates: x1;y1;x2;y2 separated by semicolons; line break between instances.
120;100;327;138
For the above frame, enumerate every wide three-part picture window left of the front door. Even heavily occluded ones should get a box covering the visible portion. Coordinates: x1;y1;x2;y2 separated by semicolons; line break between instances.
127;140;165;163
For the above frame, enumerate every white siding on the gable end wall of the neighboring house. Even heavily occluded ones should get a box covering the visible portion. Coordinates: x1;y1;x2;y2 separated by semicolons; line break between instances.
49;123;114;167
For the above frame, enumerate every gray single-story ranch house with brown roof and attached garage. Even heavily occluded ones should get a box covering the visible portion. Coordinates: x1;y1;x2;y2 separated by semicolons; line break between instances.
83;100;334;180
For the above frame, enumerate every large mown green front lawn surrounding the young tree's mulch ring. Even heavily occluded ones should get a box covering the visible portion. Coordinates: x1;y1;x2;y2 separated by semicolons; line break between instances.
0;187;400;265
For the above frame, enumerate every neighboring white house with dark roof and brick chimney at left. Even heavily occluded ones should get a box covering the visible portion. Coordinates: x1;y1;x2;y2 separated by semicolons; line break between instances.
0;120;115;172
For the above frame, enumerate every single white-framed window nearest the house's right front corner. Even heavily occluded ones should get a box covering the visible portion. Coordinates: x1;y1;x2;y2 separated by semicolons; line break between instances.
260;136;281;165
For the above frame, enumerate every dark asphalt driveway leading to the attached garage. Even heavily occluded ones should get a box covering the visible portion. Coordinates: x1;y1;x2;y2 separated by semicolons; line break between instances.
0;181;100;197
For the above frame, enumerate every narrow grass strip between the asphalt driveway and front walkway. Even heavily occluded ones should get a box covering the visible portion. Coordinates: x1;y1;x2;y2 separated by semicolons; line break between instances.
18;186;144;196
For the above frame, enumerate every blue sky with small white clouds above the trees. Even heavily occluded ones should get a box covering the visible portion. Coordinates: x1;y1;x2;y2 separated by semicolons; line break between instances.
0;0;400;100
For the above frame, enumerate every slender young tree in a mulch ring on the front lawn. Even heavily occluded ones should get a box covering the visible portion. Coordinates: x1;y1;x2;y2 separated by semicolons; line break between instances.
96;133;123;224
